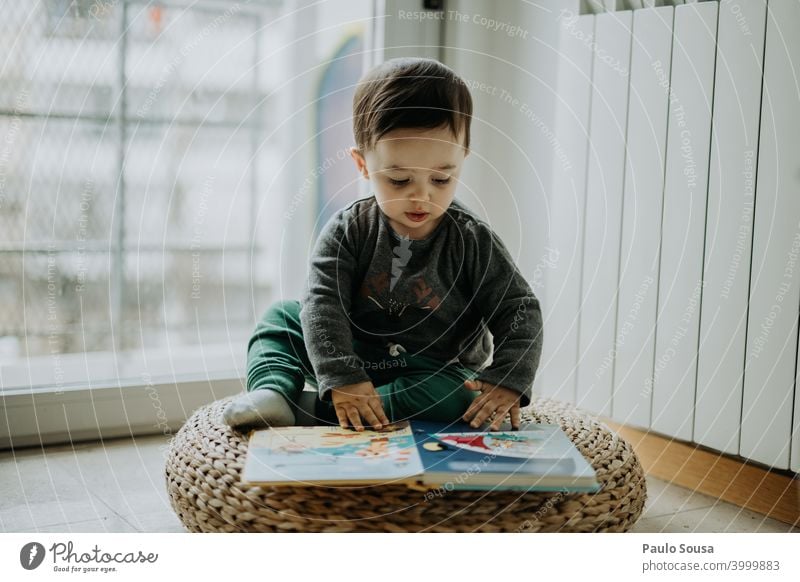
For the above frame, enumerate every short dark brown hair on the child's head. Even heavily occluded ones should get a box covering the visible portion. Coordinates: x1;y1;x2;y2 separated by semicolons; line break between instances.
353;57;472;153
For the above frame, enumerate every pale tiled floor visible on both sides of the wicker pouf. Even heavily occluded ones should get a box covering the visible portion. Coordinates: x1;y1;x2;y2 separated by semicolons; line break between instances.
0;436;800;533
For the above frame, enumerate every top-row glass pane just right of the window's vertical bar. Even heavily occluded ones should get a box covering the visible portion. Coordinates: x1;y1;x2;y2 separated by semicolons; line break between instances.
126;3;259;123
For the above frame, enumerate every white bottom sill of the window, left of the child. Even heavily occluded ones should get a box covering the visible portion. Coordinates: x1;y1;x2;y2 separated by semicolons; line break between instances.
0;345;245;450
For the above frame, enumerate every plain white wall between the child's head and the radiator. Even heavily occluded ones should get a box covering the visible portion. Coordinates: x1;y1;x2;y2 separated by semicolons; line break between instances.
442;0;578;284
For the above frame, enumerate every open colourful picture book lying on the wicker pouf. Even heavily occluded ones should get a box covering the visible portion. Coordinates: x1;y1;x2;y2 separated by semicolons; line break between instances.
242;420;600;493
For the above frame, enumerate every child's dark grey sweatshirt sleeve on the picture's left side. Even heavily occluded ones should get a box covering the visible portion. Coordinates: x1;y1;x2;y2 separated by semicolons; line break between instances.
300;211;370;401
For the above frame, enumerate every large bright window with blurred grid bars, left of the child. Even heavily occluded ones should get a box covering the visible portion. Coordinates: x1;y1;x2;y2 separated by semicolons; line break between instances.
0;0;372;390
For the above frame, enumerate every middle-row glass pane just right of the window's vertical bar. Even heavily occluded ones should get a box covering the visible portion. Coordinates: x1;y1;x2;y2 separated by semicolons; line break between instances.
125;125;253;249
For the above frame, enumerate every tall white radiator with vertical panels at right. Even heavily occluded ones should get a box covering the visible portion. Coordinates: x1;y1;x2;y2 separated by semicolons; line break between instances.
536;0;800;472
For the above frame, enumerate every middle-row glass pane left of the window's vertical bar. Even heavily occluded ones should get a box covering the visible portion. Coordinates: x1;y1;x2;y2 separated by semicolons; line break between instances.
0;116;119;249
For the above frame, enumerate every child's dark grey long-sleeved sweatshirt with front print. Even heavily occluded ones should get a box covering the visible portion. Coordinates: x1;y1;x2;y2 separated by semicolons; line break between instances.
300;196;542;406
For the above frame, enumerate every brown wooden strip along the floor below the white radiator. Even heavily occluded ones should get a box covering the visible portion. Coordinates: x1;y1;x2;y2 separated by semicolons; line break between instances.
602;418;800;526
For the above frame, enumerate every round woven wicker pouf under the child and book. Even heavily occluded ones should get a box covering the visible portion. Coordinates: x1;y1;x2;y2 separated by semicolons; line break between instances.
166;398;646;532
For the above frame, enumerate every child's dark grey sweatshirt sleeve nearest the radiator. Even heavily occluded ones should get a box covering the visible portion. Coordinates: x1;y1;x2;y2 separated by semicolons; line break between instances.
471;223;543;406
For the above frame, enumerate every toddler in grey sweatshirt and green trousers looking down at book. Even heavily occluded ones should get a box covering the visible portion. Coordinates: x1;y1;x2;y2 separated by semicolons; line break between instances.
223;58;542;430
